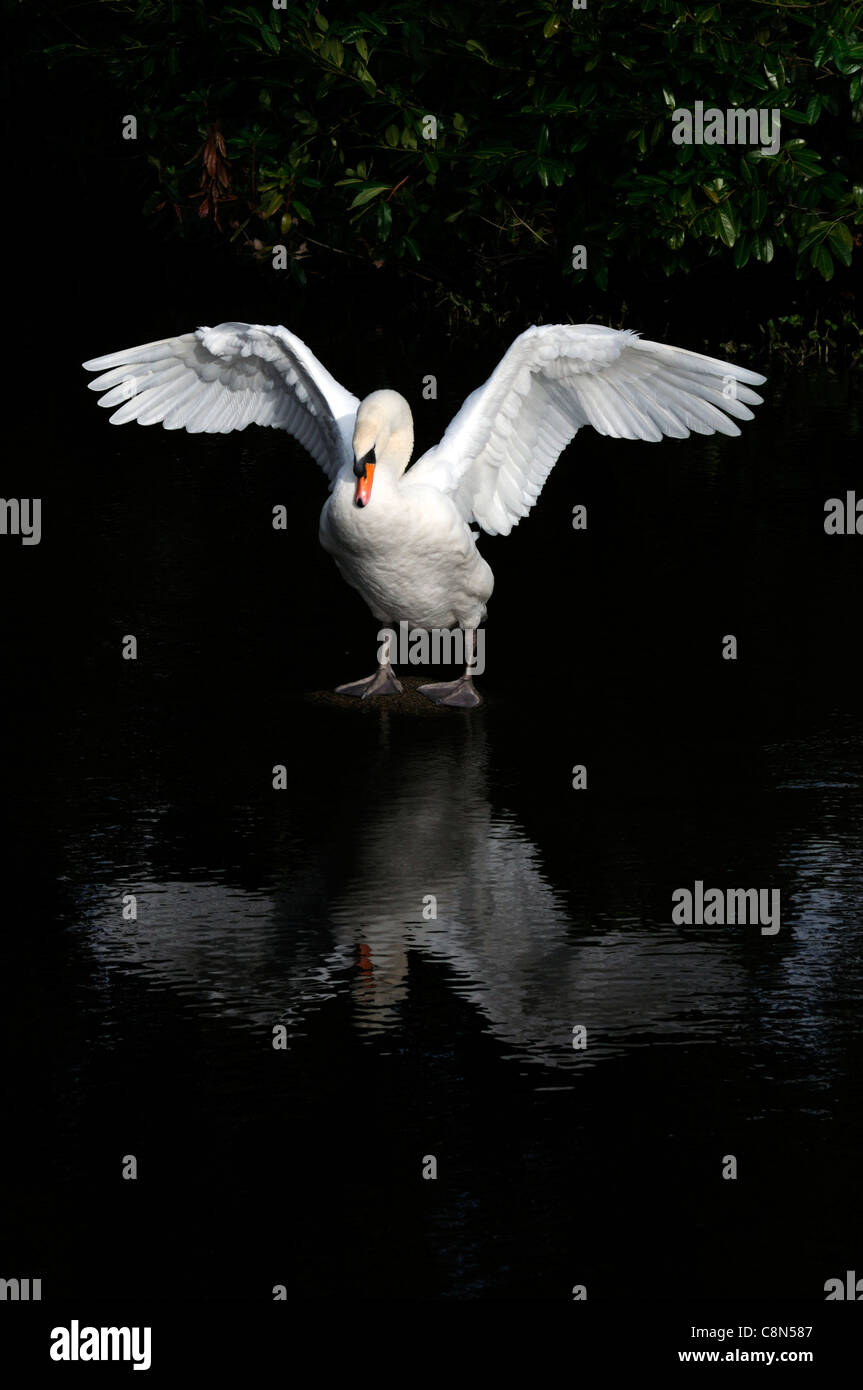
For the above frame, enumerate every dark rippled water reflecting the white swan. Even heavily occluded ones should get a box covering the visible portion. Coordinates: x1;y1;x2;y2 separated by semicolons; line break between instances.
1;355;863;1302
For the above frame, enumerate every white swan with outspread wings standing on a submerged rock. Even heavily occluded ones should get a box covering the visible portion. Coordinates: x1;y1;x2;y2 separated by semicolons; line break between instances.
83;322;764;708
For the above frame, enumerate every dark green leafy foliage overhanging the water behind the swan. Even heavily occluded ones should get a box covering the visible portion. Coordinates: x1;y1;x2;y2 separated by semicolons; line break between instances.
42;0;863;336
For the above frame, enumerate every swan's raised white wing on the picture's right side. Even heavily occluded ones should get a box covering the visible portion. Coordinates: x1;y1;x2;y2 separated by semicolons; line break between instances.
404;324;766;535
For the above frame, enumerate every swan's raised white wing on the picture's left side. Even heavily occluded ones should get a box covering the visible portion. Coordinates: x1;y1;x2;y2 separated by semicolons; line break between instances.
83;324;360;485
